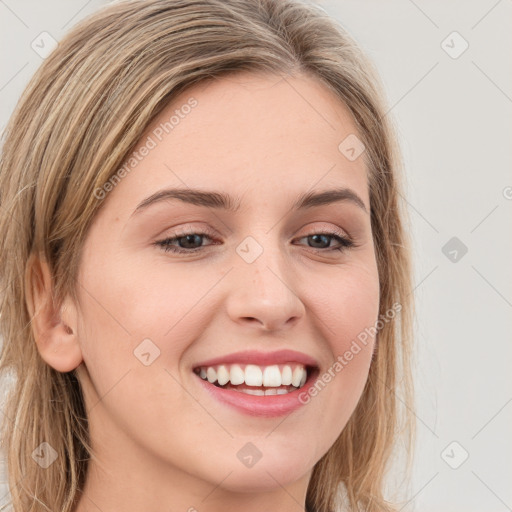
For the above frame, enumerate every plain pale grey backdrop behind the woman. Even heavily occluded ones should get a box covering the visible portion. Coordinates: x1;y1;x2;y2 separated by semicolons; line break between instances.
0;0;512;512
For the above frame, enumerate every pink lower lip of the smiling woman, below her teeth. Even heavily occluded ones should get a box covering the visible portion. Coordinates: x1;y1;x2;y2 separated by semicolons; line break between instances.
194;370;318;418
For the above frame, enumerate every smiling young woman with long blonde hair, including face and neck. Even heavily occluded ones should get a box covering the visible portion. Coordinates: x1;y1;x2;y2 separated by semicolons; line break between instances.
0;0;414;512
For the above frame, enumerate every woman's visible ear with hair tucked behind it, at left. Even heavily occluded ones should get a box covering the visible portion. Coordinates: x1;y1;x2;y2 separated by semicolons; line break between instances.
25;254;82;372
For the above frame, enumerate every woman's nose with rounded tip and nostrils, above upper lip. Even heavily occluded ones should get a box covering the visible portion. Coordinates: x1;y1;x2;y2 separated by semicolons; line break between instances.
227;243;305;331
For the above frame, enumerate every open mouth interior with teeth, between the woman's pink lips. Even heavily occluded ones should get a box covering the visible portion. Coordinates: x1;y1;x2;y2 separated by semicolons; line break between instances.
194;362;318;396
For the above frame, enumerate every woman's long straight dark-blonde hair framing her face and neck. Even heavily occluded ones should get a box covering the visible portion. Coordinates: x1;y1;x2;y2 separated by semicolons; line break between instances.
0;0;415;512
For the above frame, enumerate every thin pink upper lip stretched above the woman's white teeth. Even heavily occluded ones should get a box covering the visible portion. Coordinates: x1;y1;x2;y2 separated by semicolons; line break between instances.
195;350;318;368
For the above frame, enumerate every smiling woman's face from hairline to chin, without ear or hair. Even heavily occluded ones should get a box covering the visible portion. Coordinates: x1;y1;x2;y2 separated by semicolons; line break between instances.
71;73;379;499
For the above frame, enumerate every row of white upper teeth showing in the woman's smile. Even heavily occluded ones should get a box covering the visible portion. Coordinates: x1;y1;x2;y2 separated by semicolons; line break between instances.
199;364;307;387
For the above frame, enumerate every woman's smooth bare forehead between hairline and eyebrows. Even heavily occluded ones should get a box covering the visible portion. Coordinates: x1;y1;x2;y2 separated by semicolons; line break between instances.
99;69;368;213
